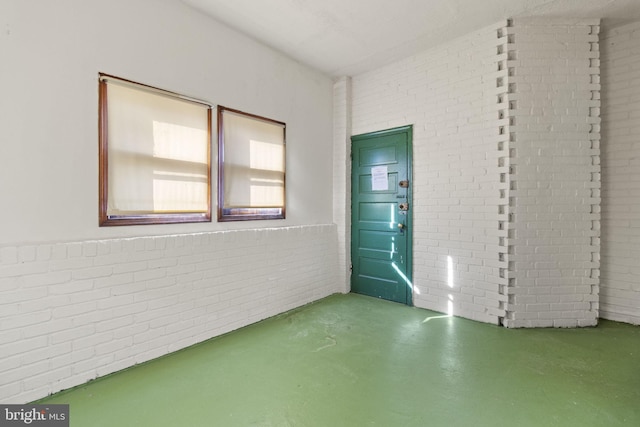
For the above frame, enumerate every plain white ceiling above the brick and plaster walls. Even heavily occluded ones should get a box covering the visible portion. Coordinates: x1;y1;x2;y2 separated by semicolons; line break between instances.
182;0;640;76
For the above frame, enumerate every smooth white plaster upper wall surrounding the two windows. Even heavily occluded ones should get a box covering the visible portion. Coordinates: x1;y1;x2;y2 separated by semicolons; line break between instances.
0;0;333;245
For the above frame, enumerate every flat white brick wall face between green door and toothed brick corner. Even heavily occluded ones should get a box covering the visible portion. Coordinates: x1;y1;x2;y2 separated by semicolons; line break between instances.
352;22;506;323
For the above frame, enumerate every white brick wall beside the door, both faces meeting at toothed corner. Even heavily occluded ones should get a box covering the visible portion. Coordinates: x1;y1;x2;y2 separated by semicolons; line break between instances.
344;20;600;327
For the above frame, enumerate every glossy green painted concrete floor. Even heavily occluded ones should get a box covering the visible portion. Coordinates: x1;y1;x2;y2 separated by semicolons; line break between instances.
38;294;640;427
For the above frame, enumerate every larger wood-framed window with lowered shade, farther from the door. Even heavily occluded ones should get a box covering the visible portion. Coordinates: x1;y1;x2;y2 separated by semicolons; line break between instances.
99;74;211;226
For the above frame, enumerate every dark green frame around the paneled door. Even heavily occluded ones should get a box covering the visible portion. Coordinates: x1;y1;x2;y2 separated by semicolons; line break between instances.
349;125;414;306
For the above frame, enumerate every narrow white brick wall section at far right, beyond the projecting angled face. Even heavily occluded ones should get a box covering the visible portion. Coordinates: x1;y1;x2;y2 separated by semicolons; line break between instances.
600;22;640;324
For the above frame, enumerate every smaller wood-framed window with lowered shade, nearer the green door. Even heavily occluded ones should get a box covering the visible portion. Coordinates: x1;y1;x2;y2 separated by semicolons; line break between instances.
218;107;286;221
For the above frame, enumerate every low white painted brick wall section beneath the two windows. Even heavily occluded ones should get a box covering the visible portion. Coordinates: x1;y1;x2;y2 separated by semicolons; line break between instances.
0;225;343;403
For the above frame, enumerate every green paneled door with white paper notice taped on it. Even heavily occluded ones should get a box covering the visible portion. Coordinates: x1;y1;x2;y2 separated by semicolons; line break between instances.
351;126;412;305
